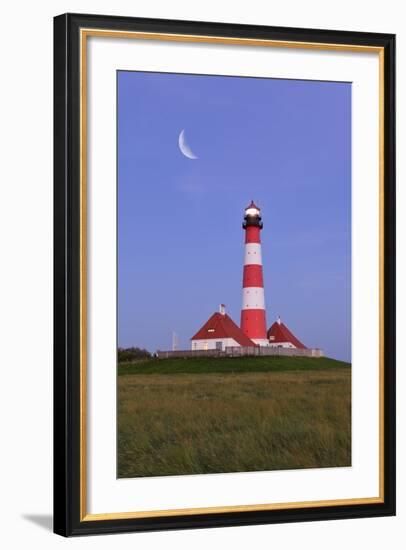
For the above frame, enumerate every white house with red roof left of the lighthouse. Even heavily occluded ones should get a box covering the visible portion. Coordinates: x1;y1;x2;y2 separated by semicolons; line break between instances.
191;304;256;351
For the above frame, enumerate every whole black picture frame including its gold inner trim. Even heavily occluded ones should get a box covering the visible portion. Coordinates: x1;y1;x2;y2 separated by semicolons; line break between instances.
54;14;395;536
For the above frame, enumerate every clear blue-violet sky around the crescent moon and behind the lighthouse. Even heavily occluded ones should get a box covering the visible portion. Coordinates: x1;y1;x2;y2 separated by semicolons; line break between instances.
118;71;351;361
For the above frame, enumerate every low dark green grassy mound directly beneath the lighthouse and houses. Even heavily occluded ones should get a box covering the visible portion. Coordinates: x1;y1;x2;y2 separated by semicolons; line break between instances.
118;356;351;376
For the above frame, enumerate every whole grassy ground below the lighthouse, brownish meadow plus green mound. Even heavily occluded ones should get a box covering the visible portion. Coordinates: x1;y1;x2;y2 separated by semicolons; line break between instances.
117;357;351;477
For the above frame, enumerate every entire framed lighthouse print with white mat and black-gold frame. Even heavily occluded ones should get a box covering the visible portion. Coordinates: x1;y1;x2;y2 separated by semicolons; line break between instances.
54;14;395;536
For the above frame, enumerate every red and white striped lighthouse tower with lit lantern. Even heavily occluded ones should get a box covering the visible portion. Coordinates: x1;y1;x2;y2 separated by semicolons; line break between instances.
241;201;269;346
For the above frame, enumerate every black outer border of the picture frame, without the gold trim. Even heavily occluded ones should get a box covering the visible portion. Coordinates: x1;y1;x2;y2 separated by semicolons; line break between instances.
54;14;396;536
